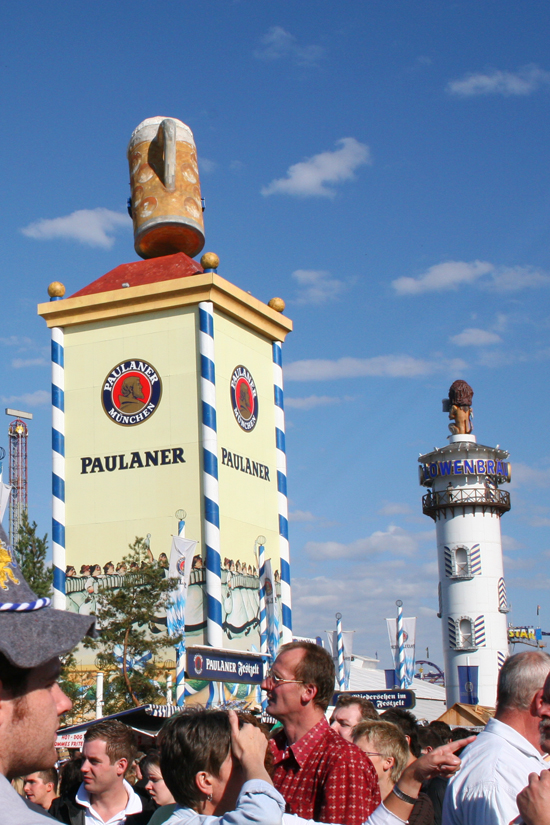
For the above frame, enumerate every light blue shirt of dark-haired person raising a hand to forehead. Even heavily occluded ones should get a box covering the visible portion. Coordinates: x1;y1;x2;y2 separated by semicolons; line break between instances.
166;779;285;825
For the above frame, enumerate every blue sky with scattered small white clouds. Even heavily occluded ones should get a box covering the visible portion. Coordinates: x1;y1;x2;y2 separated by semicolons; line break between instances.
0;0;550;665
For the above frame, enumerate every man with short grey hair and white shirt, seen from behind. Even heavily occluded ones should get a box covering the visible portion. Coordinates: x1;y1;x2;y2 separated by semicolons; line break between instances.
443;651;550;825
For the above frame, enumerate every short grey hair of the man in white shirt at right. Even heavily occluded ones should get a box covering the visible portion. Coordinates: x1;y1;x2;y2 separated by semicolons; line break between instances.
497;650;550;716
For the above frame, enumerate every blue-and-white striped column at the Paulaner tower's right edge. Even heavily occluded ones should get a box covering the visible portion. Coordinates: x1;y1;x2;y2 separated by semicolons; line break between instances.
273;341;292;644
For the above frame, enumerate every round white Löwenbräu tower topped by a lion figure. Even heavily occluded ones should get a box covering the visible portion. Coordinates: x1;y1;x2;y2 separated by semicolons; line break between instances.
418;381;510;707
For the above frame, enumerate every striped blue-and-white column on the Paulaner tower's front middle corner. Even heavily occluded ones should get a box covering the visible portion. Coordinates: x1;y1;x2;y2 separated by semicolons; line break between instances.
199;301;223;647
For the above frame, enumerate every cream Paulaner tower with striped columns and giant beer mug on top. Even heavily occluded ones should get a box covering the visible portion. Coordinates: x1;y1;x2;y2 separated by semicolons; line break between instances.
39;117;292;668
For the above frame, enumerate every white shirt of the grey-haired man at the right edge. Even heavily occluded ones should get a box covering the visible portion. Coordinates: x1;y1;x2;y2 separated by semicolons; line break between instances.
443;719;548;825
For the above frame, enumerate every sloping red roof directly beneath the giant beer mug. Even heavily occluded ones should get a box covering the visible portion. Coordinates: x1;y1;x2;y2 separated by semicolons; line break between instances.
70;252;203;298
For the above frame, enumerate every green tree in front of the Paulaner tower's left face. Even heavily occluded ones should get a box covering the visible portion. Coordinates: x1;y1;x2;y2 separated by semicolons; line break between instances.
85;538;179;715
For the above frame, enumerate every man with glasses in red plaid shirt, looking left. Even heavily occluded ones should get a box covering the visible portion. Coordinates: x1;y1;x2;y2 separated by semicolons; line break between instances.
262;642;380;825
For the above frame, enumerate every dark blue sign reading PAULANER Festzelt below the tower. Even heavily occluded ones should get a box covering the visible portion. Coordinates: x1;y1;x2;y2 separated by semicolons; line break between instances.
186;647;265;685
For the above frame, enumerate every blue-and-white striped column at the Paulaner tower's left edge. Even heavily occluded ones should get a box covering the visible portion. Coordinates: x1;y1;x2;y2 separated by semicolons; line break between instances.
50;318;66;610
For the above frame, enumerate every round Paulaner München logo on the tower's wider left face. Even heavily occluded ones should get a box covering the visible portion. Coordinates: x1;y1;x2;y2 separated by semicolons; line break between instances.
101;360;162;427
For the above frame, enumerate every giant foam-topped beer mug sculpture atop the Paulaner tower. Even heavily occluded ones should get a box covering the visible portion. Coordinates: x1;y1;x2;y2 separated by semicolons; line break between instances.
128;117;204;258
